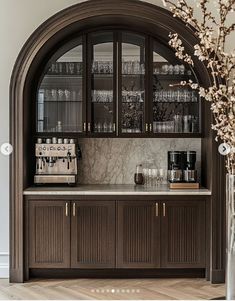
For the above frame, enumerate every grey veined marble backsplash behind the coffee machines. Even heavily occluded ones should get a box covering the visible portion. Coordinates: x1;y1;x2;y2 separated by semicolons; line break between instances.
78;138;201;184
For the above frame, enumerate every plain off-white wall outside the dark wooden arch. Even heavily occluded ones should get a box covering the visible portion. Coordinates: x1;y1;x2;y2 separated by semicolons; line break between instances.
0;0;234;277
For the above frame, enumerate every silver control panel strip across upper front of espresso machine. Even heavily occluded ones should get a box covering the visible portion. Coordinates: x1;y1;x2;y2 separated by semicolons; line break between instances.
35;143;76;158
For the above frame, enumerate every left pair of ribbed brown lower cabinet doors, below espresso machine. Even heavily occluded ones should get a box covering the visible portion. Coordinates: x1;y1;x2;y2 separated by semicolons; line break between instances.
27;200;115;269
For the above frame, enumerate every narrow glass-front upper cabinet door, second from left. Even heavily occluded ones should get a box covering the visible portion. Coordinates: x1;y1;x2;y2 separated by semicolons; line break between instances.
87;31;116;135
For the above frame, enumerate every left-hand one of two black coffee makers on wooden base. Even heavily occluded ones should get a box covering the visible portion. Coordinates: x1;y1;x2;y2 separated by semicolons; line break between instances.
168;151;183;183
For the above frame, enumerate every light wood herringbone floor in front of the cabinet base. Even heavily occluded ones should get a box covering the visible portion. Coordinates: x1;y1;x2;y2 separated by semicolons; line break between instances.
0;278;225;300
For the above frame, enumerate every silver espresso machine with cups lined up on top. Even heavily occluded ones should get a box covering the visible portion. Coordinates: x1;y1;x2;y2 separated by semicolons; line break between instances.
34;138;77;184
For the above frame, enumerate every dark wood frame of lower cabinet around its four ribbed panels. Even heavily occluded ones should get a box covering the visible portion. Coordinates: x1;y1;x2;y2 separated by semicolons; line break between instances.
24;195;207;281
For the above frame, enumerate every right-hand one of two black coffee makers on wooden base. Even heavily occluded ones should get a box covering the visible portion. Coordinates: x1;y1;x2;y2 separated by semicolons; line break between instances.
182;151;197;183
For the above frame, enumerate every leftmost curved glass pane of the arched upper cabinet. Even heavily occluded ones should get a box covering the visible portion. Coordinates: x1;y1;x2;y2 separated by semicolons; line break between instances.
37;38;84;133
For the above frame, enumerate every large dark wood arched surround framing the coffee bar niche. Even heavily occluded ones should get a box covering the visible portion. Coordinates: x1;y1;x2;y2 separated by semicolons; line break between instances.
10;0;225;282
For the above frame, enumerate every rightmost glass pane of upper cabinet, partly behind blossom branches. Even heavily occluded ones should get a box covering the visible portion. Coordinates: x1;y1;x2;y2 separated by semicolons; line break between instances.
152;41;200;134
